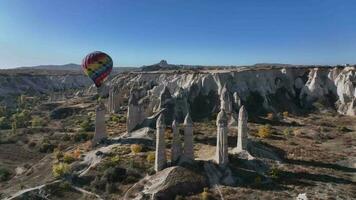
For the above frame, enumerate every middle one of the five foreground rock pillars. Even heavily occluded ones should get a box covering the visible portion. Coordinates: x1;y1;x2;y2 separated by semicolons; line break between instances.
184;113;194;160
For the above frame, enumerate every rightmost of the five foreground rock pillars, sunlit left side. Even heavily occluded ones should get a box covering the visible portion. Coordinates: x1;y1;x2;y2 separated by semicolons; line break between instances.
236;106;247;151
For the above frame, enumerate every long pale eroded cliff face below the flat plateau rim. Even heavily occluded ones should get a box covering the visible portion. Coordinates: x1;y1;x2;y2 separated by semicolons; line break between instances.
112;67;356;120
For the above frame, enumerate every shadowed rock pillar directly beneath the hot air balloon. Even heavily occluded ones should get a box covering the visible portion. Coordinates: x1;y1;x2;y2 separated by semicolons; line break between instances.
93;101;107;144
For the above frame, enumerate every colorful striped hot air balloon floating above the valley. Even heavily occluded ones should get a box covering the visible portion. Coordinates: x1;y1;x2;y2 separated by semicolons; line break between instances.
82;51;113;88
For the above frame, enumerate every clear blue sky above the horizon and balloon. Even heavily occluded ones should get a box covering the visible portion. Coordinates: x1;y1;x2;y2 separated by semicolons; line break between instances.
0;0;356;68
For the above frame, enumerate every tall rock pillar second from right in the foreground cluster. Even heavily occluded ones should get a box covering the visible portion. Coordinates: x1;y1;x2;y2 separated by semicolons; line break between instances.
215;109;229;166
